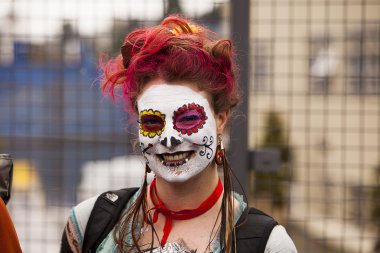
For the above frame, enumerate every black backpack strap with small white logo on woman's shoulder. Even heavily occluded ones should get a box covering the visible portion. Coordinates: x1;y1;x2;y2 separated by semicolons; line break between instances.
82;188;139;253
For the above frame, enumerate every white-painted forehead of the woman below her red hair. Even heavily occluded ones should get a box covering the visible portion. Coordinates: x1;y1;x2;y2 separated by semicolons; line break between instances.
137;84;209;110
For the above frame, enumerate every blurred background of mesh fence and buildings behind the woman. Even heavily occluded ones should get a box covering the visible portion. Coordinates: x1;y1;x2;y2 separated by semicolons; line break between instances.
0;0;380;253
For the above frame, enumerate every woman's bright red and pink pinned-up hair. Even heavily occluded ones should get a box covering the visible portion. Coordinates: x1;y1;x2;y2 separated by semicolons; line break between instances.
101;16;239;113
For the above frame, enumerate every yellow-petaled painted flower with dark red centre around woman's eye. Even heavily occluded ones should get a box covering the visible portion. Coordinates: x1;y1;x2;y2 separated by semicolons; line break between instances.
139;109;165;138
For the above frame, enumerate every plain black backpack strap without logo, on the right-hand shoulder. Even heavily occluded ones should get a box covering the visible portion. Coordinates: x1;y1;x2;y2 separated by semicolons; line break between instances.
236;208;278;253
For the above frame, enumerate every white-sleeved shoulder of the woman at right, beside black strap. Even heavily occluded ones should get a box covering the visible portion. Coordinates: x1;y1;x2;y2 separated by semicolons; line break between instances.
265;225;297;253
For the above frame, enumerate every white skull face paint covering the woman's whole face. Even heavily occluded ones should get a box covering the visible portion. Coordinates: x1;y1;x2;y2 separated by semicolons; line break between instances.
137;84;216;182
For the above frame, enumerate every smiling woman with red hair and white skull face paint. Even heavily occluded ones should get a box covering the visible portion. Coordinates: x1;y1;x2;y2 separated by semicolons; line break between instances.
61;16;296;252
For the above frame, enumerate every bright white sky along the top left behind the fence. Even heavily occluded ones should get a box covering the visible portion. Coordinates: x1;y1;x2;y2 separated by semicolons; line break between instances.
0;0;228;41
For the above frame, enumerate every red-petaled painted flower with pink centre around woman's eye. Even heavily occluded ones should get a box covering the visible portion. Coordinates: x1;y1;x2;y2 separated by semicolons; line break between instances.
173;103;207;135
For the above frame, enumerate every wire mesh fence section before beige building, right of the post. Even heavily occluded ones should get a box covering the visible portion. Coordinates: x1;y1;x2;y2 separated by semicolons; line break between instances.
249;0;380;252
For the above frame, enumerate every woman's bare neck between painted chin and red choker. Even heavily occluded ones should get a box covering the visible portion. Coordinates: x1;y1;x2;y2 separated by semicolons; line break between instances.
149;165;219;211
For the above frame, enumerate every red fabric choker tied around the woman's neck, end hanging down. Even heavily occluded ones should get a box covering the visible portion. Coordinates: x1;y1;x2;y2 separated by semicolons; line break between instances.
150;179;223;247
